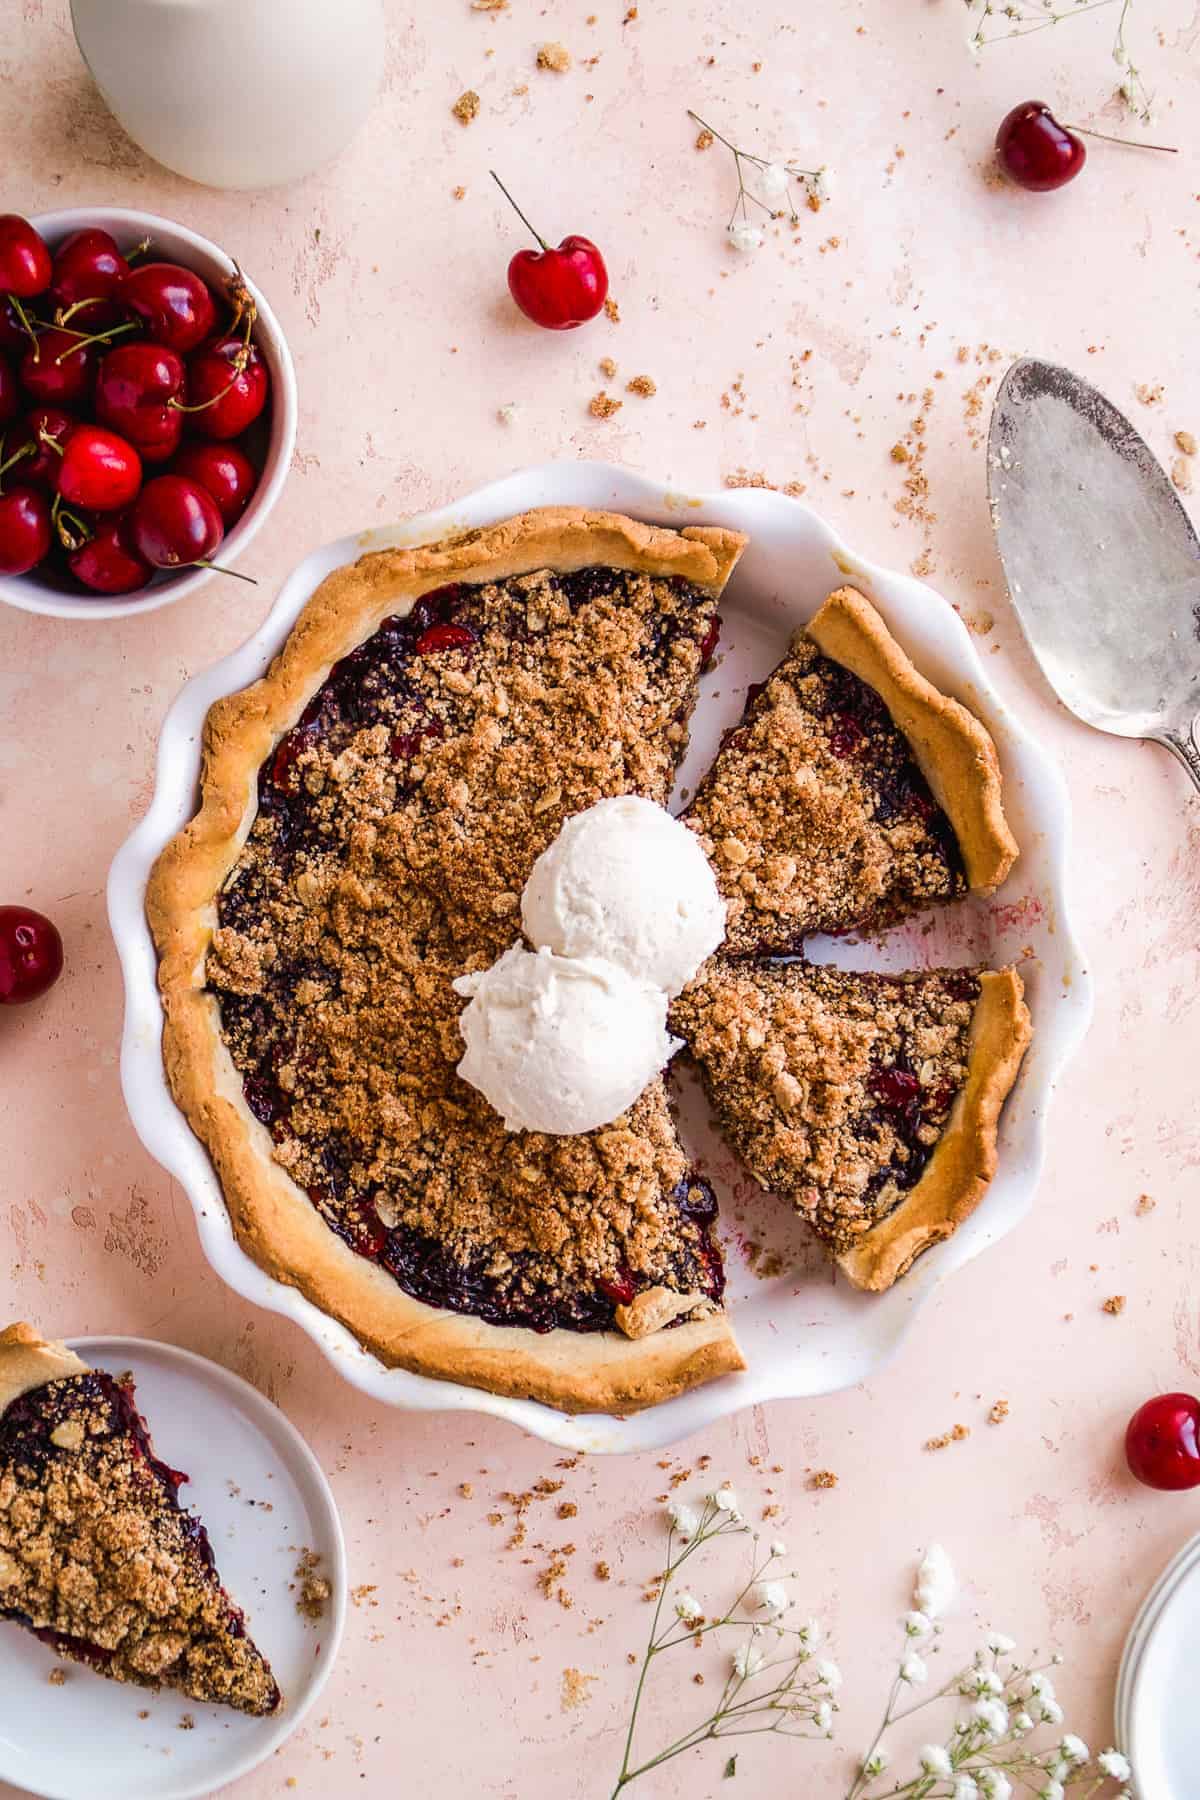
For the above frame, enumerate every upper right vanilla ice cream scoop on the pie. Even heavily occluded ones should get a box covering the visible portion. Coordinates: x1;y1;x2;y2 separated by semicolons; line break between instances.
522;794;725;995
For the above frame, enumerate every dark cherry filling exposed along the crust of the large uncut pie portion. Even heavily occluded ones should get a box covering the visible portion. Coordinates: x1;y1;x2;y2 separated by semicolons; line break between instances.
218;565;725;1332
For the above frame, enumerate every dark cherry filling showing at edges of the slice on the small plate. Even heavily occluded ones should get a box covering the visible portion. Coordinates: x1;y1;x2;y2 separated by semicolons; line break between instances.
0;1370;255;1669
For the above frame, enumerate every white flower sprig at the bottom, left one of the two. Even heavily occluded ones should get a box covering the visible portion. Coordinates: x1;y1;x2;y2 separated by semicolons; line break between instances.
613;1483;842;1800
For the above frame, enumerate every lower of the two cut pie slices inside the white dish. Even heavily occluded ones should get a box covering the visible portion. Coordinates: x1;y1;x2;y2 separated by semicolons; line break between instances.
671;956;1029;1292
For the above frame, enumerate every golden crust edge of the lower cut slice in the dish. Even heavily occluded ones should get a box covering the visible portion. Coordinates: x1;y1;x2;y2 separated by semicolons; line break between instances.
837;968;1033;1294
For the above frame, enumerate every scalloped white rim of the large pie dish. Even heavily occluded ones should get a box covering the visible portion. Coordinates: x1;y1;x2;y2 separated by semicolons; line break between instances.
108;461;1092;1453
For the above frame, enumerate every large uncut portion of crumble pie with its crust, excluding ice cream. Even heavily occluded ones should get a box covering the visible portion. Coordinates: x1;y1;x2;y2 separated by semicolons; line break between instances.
148;508;743;1411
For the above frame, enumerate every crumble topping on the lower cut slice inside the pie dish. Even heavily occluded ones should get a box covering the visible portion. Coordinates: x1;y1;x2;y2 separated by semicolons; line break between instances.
669;956;979;1253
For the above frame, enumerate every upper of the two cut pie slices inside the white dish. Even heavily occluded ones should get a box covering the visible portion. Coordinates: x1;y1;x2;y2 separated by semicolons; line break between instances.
687;587;1016;956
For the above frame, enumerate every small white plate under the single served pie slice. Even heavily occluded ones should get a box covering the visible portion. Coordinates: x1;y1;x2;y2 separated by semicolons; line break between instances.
0;1337;347;1800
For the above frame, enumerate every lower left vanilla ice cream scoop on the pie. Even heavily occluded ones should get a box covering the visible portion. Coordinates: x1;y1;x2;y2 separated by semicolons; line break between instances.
453;945;680;1136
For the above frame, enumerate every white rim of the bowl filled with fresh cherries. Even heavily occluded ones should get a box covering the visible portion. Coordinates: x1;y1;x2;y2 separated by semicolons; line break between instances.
0;205;299;621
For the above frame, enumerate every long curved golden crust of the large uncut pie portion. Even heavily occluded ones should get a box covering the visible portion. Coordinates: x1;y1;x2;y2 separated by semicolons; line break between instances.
146;508;745;1413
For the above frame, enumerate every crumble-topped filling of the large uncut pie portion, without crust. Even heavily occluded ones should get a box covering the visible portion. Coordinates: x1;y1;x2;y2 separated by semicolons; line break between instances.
207;567;720;1330
